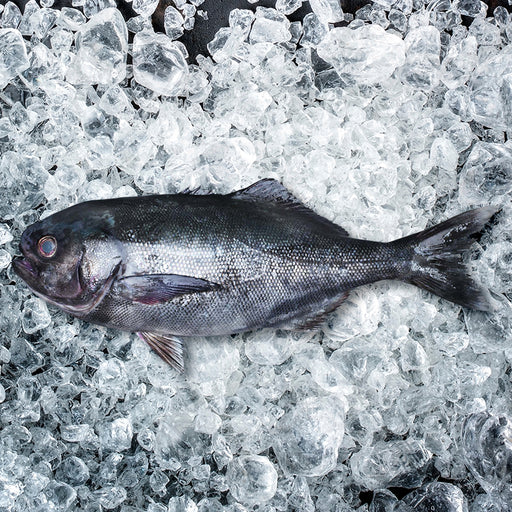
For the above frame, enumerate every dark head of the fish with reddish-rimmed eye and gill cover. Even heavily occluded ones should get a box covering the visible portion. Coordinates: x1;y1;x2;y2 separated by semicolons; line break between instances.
12;203;120;316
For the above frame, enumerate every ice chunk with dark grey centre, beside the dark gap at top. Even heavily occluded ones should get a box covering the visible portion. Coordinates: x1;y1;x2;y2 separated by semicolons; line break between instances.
133;30;188;96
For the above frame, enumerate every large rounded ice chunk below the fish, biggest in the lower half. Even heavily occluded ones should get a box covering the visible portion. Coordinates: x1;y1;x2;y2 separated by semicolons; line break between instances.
274;397;344;476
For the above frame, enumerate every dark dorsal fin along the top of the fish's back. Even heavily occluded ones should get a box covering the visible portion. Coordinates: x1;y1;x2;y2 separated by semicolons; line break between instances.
231;178;349;236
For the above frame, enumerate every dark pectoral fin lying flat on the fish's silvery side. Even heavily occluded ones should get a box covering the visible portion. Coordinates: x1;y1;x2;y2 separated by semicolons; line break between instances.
116;274;219;305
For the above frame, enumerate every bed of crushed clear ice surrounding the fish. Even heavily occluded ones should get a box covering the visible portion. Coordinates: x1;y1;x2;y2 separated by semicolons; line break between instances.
0;0;512;512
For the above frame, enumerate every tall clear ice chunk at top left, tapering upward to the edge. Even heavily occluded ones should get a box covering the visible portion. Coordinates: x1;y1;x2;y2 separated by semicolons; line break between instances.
67;8;128;84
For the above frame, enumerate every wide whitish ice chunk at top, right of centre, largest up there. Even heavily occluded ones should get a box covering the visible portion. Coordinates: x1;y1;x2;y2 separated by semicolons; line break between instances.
318;25;405;84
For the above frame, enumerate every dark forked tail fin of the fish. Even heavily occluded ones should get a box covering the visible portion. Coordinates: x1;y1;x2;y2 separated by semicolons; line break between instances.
393;206;498;311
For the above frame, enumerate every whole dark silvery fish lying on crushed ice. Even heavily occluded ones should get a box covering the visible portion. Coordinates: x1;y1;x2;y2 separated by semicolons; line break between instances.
12;179;497;371
